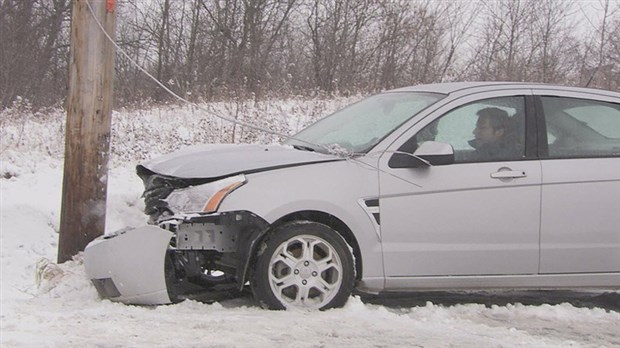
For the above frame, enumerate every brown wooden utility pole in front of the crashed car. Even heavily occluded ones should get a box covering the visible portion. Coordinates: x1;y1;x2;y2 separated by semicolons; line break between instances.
58;0;116;263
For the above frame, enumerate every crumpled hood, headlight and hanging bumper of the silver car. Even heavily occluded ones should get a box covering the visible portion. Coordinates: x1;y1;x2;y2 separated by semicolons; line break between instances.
86;144;352;304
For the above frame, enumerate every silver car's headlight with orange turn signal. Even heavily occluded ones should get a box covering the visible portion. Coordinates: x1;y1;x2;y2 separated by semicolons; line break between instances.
166;174;246;213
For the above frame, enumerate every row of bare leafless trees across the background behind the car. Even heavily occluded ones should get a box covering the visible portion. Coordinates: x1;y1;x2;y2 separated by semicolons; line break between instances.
0;0;620;108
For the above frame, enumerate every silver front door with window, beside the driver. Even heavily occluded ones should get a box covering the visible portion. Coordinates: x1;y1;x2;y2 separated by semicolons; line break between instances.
379;90;541;282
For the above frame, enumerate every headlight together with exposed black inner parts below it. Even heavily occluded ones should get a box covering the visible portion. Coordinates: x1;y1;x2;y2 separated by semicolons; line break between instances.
139;171;260;301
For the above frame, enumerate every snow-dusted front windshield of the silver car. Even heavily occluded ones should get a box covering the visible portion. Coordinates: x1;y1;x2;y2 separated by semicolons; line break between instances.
284;92;445;153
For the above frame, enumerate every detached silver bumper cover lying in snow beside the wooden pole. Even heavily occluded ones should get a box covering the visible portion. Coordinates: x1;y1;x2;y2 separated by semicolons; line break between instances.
84;226;173;305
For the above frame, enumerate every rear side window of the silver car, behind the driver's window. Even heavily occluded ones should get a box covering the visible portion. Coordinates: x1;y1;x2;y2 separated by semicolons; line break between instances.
541;97;620;158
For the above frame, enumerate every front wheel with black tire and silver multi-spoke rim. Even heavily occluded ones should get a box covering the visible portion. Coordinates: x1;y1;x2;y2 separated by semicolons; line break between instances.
250;221;355;310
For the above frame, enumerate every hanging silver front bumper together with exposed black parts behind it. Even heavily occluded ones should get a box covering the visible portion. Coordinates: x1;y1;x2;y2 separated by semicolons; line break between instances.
84;211;268;305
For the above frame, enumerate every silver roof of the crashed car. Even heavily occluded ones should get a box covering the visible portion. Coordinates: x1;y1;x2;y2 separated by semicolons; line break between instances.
388;81;620;98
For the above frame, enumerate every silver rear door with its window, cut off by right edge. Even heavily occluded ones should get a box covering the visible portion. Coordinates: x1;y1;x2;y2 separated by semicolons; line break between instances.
536;90;620;274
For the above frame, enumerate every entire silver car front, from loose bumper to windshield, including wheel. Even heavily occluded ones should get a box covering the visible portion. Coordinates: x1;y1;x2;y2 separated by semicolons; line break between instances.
85;92;443;309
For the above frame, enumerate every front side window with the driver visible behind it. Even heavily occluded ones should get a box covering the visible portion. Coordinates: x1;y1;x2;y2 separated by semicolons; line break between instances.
400;96;525;163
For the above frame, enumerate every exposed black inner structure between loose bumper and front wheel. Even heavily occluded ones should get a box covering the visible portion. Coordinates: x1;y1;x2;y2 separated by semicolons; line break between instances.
160;211;269;298
